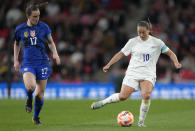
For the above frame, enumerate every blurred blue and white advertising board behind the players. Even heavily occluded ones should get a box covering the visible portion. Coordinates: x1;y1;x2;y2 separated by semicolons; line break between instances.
0;83;195;99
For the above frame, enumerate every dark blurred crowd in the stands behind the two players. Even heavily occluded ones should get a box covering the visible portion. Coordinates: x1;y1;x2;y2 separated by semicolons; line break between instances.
0;0;195;83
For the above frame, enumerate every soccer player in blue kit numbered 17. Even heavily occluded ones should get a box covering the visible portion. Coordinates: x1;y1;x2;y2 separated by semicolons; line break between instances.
14;3;60;125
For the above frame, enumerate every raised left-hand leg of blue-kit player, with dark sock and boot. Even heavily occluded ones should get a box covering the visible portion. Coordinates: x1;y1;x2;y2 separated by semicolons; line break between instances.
23;72;36;113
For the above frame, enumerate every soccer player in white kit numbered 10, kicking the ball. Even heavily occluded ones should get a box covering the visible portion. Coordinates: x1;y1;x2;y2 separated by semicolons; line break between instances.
91;21;182;127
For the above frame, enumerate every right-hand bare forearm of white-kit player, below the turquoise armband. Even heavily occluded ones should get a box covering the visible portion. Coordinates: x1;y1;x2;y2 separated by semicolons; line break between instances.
165;49;182;69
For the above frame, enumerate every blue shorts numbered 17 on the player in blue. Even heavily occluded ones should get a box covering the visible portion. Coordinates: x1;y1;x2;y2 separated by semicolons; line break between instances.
20;64;51;80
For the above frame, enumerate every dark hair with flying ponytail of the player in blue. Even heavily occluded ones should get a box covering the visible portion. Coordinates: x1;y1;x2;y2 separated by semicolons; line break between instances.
25;2;48;16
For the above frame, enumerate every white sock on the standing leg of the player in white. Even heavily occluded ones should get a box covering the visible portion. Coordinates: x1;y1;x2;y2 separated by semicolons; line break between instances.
139;99;150;122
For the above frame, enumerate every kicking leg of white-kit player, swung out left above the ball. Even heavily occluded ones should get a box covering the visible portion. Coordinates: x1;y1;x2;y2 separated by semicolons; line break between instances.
91;84;135;110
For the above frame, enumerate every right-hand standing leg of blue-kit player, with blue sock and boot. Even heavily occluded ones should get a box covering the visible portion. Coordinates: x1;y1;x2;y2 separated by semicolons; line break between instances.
33;79;47;125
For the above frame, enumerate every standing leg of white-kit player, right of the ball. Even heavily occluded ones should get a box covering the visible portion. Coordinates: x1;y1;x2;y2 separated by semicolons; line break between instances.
138;80;153;127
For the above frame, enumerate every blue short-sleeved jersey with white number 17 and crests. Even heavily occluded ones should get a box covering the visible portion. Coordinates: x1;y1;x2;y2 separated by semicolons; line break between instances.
14;21;51;65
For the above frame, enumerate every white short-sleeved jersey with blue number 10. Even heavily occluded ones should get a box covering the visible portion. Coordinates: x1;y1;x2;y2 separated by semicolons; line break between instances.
121;35;169;78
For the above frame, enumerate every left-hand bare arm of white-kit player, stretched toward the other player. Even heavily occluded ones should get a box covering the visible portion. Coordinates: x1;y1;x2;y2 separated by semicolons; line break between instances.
103;51;124;72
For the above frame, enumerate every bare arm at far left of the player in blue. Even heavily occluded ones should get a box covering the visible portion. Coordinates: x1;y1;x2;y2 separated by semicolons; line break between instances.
14;40;21;71
